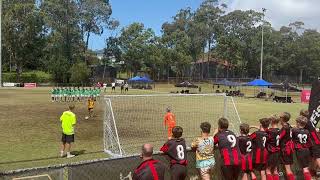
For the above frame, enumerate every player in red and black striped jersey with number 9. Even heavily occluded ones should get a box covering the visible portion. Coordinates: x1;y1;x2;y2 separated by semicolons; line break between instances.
214;118;240;180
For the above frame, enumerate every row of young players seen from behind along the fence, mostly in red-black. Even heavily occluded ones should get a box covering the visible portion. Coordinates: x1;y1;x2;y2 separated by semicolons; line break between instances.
138;111;320;180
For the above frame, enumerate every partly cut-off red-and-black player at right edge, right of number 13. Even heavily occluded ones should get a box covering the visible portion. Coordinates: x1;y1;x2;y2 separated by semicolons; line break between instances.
300;110;320;169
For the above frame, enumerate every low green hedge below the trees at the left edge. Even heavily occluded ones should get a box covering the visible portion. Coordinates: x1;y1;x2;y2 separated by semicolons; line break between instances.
2;71;52;83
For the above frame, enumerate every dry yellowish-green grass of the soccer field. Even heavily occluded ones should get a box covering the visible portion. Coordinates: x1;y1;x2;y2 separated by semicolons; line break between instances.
0;85;307;170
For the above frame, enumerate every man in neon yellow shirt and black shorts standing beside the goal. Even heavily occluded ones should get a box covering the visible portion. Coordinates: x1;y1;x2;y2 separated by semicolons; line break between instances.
60;105;77;158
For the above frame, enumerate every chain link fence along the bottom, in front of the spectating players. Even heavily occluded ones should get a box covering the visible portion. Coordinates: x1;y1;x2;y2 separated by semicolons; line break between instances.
0;151;303;180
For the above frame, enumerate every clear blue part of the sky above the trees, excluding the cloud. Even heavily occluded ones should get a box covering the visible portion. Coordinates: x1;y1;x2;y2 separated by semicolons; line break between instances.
89;0;202;50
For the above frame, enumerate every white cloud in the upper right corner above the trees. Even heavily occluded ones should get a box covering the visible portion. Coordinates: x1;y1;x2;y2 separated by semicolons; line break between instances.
225;0;320;31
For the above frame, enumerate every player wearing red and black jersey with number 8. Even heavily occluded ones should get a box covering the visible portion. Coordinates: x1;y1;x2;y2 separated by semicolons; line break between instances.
160;126;188;180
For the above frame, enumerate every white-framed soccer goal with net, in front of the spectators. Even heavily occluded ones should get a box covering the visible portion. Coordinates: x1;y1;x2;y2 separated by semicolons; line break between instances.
103;94;241;156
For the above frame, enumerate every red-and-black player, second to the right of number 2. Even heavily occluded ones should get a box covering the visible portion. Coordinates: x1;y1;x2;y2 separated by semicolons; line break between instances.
266;115;280;180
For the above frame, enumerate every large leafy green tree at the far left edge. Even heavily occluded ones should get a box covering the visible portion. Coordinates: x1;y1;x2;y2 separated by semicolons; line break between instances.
1;0;44;82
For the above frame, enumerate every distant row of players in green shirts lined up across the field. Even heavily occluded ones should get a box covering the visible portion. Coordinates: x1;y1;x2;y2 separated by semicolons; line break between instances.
51;87;101;102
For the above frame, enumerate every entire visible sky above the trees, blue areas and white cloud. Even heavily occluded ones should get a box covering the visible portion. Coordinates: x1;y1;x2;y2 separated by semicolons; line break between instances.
89;0;320;50
